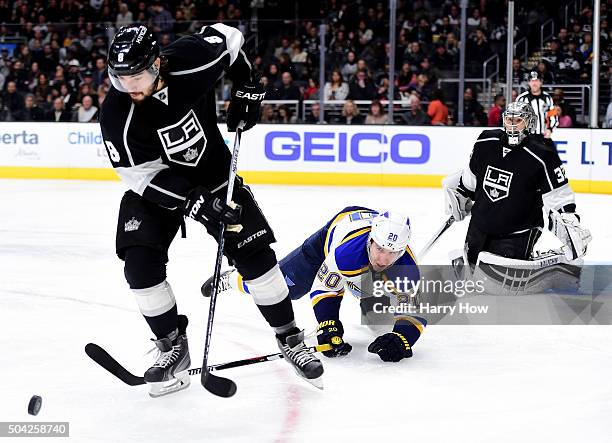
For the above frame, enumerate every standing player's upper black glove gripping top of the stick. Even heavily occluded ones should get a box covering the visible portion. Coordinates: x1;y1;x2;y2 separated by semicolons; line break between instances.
227;79;266;132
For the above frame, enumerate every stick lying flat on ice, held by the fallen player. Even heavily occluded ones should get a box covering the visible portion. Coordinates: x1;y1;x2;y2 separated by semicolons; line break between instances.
85;343;331;386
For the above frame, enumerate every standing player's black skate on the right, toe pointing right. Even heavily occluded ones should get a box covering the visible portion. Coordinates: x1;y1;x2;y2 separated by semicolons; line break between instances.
276;331;323;389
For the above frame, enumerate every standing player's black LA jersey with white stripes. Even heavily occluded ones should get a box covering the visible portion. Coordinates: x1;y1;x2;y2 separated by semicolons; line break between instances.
100;24;251;208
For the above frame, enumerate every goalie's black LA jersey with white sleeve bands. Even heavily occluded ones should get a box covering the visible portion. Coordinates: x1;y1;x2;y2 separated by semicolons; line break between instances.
461;129;575;235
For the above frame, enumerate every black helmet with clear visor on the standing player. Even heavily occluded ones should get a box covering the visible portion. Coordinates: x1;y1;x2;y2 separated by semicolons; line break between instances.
108;25;159;92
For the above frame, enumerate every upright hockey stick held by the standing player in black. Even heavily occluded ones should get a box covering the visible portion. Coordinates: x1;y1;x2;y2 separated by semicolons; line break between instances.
200;121;245;397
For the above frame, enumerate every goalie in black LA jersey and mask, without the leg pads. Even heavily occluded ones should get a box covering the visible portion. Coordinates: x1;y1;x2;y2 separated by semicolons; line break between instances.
443;102;590;266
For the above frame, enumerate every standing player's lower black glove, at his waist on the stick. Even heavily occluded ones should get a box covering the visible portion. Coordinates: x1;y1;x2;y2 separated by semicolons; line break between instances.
183;186;242;225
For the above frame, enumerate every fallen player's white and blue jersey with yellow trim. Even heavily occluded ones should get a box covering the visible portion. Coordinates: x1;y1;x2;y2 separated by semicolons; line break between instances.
234;206;426;345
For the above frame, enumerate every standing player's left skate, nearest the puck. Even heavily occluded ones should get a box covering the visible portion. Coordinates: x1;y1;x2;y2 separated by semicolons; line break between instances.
144;315;191;398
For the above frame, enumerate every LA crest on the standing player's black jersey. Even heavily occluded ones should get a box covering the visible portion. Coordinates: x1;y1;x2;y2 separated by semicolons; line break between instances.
157;110;206;167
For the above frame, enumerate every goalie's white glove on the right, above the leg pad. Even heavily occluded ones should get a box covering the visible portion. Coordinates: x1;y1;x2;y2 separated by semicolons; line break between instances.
548;211;592;260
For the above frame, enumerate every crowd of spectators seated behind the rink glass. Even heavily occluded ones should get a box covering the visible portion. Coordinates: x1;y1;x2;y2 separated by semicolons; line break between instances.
0;0;612;126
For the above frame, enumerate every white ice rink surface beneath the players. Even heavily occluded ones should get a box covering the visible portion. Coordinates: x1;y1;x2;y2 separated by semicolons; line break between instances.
0;180;612;443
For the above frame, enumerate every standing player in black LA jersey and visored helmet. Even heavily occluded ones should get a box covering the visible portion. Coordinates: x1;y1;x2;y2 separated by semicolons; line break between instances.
100;24;323;396
